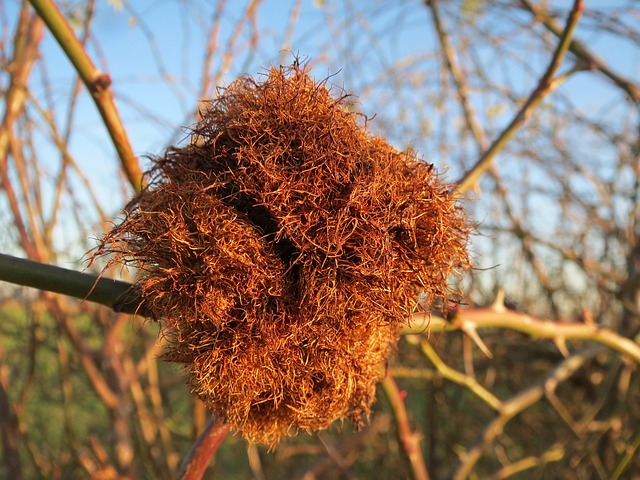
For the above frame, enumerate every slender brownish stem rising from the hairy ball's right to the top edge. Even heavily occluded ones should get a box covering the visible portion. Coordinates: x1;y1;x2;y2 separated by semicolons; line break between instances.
454;0;584;196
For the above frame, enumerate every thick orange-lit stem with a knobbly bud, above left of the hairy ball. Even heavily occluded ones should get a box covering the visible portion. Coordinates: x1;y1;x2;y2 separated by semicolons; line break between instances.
29;0;144;192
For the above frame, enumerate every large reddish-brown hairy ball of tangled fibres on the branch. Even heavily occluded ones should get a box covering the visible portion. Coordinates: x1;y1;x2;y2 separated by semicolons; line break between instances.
102;66;469;444
